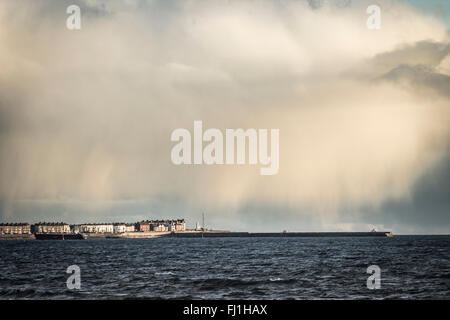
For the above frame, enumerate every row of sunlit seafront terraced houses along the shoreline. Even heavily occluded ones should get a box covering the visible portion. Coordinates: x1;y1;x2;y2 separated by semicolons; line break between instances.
0;219;186;234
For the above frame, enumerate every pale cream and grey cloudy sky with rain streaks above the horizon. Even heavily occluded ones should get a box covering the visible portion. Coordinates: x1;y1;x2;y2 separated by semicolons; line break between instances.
0;0;450;234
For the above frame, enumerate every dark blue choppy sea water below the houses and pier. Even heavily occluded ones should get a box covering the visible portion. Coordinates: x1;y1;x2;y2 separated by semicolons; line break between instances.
0;236;450;299
